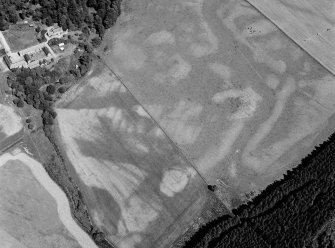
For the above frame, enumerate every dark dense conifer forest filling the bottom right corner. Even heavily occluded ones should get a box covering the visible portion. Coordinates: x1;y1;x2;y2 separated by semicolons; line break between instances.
184;134;335;248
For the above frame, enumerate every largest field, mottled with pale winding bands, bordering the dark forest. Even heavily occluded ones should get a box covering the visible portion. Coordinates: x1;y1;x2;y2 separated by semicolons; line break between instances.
101;0;335;208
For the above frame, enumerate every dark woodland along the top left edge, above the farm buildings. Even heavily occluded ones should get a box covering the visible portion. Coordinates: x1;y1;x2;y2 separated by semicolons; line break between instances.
0;0;121;37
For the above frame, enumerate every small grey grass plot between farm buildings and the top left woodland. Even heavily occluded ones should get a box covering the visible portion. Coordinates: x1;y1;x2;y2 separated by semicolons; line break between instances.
2;24;39;52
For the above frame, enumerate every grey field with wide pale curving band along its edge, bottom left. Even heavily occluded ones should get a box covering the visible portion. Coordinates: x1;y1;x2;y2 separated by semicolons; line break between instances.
0;150;96;248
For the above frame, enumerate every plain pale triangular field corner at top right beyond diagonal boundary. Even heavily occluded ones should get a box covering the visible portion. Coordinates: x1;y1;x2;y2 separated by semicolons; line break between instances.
247;0;335;75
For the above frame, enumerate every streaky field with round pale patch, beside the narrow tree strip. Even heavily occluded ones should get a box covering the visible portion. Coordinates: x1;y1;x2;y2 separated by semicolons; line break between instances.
56;63;214;248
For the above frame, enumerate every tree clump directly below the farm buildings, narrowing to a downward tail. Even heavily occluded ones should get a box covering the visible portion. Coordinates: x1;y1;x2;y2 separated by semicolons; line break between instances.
7;45;92;137
